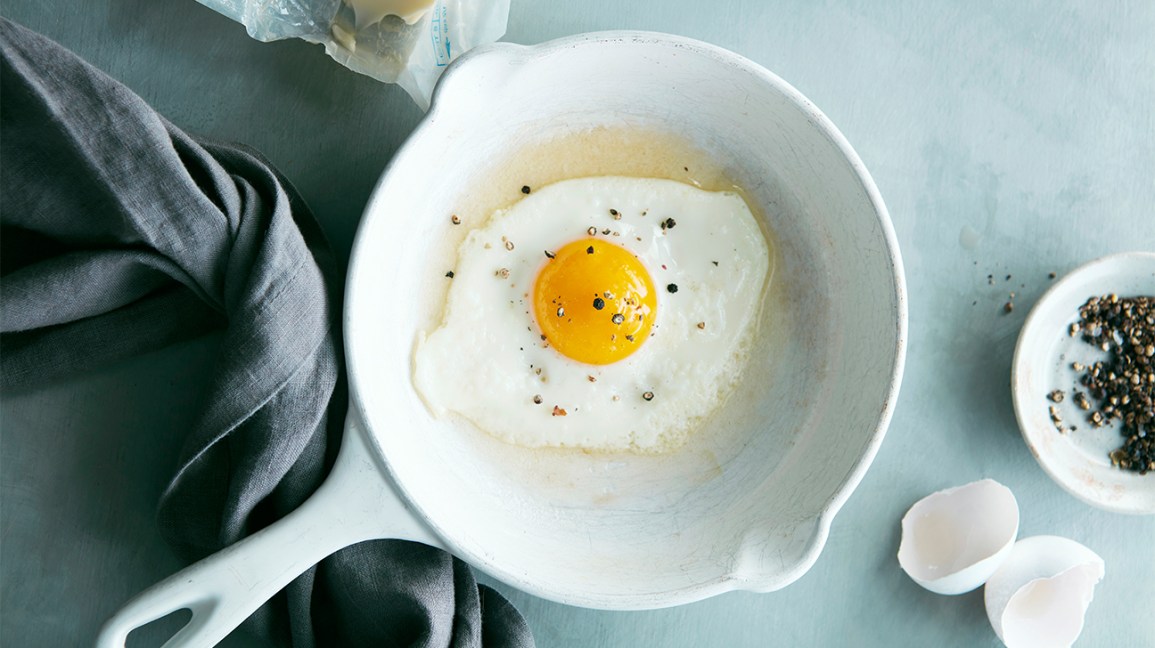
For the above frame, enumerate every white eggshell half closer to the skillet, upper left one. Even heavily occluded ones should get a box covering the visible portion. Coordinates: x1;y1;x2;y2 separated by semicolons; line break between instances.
899;479;1019;594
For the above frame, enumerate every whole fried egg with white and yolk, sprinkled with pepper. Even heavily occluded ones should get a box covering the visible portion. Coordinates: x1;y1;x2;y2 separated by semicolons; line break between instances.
413;177;770;453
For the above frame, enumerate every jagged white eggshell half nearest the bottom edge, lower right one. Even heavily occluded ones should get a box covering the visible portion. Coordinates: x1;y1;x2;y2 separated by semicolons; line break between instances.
984;536;1104;648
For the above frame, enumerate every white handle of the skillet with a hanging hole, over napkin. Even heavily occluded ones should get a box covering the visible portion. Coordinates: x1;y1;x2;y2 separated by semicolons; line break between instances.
96;408;442;648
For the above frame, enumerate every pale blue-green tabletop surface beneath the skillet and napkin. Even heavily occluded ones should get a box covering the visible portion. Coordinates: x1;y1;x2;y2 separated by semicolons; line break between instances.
0;0;1155;647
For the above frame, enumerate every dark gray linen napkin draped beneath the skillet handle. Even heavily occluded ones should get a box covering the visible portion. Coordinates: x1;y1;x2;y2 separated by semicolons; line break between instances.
0;18;534;647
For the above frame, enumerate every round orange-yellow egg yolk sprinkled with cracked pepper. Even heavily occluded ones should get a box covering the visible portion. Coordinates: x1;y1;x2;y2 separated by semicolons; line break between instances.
534;238;657;365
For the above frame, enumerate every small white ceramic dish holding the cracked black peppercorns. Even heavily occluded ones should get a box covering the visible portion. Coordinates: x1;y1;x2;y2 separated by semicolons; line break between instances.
1011;252;1155;514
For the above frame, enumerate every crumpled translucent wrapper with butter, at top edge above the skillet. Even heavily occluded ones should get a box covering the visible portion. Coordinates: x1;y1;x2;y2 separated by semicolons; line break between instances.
198;0;509;110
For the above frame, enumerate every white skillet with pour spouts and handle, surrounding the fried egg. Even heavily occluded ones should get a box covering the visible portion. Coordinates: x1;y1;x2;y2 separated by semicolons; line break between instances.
98;32;907;646
